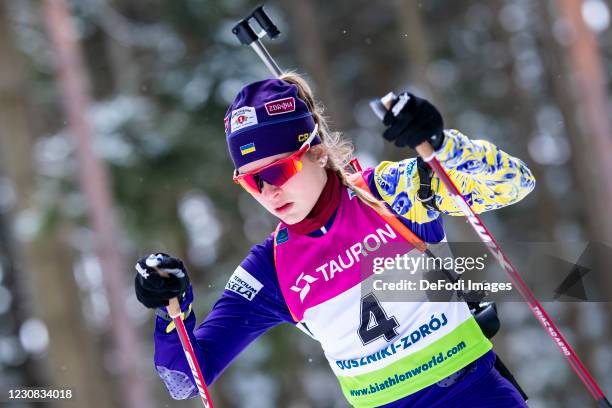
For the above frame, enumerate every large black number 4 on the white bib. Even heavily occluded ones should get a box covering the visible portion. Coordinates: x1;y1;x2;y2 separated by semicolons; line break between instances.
357;293;399;346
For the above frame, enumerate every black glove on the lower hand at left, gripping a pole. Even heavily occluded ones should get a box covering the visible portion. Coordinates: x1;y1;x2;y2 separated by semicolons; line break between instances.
134;253;189;309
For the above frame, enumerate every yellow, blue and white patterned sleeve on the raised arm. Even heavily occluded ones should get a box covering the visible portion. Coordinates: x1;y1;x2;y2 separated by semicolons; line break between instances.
374;130;535;225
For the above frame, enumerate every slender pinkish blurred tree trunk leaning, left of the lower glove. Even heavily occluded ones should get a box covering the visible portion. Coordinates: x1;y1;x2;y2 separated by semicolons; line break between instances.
44;0;153;408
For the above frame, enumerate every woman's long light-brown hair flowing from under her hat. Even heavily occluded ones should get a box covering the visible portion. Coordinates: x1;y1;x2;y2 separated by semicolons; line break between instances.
280;72;389;214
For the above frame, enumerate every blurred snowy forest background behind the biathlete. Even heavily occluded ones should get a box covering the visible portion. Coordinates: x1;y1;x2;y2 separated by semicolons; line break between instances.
0;0;612;408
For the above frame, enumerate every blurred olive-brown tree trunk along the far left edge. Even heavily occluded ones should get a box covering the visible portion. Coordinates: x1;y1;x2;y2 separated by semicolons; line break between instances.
0;1;116;407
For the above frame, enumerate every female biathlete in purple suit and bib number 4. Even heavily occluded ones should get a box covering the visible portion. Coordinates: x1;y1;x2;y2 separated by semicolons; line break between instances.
135;73;535;408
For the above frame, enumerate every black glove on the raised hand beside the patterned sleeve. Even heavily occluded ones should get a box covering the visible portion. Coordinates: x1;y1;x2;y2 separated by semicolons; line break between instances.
383;92;444;150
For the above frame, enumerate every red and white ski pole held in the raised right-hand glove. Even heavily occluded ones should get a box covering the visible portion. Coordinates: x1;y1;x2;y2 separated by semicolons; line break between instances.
370;92;612;408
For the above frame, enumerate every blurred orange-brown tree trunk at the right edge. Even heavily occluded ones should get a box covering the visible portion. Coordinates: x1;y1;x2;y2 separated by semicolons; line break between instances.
541;1;612;398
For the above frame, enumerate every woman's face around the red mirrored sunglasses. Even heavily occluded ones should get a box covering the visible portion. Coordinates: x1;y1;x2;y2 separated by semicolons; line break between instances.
238;152;327;225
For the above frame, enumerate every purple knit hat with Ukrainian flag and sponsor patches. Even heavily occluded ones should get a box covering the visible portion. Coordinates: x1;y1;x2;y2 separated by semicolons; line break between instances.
224;79;321;169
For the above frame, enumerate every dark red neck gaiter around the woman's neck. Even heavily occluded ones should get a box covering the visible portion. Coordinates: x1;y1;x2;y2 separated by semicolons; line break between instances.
287;169;342;235
